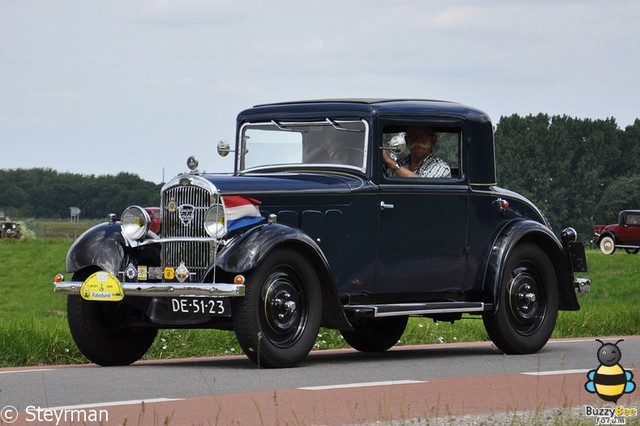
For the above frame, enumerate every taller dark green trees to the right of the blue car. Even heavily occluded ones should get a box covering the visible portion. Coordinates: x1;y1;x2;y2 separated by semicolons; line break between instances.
495;114;640;242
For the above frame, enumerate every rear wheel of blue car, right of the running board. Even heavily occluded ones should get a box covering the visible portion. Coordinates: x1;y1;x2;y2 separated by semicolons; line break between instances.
482;243;558;354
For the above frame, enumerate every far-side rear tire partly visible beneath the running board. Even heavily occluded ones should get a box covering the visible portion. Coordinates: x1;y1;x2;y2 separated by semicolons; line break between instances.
340;317;409;352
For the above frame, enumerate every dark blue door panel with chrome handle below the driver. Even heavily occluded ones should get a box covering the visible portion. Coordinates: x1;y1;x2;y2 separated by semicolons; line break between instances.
375;123;469;298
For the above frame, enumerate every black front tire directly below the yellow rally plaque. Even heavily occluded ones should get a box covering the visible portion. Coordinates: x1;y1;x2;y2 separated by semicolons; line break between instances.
67;275;158;366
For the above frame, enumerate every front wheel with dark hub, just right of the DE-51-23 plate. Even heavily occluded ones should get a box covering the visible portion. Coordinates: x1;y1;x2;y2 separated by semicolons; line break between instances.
233;249;322;368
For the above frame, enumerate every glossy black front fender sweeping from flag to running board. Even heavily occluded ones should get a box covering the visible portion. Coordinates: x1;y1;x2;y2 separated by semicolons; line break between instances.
216;224;352;330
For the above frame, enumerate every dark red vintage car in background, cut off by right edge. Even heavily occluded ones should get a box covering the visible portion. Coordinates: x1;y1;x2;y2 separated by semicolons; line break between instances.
593;210;640;254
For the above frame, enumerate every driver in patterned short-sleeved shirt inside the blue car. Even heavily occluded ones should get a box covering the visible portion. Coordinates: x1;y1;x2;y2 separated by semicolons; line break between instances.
382;126;451;178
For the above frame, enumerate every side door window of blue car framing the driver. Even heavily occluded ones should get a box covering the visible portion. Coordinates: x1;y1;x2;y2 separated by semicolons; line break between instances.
382;124;462;179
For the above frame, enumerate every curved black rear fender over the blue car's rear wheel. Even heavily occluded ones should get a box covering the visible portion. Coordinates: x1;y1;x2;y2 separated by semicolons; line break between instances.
484;220;580;310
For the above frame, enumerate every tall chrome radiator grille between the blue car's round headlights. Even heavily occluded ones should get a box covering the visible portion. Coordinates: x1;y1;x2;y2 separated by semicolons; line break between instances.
162;181;216;282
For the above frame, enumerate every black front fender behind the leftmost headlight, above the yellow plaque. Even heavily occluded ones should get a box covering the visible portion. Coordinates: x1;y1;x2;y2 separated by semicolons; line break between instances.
66;222;126;274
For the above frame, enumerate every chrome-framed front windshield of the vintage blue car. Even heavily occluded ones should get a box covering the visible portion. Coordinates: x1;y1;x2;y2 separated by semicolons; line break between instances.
238;119;368;172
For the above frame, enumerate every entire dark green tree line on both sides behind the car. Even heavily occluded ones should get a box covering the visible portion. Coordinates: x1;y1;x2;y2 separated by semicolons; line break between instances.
0;114;640;242
